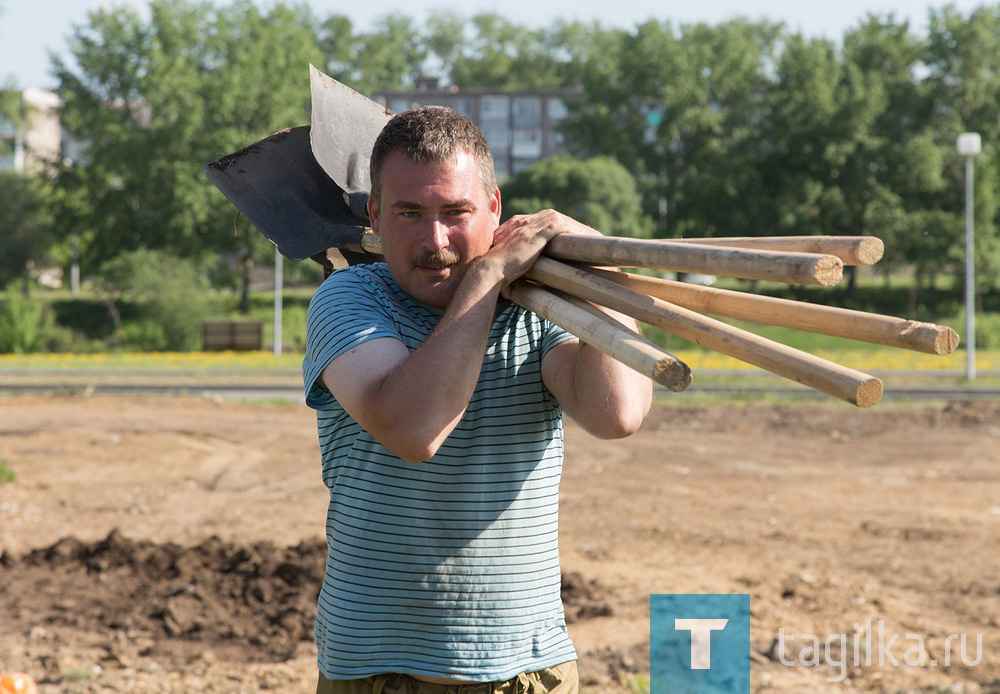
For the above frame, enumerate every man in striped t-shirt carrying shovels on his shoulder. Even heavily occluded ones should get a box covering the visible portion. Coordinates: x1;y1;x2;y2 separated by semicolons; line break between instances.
303;107;652;694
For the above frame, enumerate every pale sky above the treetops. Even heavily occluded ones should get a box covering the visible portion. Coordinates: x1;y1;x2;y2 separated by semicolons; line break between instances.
0;0;984;89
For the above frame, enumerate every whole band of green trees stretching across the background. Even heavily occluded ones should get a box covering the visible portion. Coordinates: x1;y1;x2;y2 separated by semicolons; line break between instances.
0;0;1000;312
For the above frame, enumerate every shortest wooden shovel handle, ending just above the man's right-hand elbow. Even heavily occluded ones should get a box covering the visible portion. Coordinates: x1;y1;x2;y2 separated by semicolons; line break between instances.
509;281;691;391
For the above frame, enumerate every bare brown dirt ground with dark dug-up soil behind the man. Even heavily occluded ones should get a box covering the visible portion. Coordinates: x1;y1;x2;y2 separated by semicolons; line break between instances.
0;397;1000;694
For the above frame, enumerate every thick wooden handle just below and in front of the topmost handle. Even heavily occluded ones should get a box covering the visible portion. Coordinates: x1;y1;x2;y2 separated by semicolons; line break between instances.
544;234;844;287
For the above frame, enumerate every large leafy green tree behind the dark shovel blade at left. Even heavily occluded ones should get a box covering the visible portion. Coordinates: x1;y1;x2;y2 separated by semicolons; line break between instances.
55;0;322;308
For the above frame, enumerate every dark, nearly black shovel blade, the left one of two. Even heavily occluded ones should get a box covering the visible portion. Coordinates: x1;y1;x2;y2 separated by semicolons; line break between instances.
205;126;368;260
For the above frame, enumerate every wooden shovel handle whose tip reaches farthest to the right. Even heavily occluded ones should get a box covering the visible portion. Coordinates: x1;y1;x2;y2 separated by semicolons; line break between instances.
586;268;958;354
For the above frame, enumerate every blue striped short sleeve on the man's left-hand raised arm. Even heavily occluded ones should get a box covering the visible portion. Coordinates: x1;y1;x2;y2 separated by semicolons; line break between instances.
302;267;401;409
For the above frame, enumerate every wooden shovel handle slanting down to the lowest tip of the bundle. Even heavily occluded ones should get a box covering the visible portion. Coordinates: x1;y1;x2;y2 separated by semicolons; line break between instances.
528;258;882;407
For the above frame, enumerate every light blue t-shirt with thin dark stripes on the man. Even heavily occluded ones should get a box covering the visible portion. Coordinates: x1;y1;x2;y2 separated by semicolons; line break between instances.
303;264;576;682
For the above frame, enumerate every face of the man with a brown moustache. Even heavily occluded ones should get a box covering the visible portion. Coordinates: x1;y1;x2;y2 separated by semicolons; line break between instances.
368;151;500;308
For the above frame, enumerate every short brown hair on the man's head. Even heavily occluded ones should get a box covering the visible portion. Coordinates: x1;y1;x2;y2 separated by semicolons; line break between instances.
370;106;497;200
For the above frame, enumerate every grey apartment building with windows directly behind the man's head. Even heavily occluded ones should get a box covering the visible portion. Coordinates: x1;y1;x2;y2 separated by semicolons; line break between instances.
372;78;570;180
